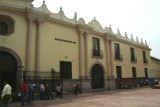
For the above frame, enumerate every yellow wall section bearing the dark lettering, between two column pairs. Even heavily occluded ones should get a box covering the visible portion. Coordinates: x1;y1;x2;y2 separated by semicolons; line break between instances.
40;22;79;78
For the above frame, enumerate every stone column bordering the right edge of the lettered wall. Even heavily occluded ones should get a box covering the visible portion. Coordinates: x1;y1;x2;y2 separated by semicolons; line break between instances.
79;31;84;78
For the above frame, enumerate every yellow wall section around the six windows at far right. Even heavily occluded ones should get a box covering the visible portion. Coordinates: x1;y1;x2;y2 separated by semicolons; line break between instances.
113;41;150;78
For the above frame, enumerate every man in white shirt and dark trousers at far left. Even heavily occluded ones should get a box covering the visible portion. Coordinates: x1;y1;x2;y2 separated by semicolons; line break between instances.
1;80;12;107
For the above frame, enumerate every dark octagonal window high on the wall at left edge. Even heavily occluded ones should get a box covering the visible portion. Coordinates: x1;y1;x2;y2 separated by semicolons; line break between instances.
0;21;9;35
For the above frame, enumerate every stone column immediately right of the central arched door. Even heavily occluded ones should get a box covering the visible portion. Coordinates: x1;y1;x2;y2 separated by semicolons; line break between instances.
106;38;111;89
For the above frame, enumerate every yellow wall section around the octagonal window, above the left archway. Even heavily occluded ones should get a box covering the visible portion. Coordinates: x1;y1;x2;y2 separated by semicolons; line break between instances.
0;11;27;69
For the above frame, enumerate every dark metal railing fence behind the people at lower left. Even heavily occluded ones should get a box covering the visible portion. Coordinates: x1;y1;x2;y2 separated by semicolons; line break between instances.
22;71;63;93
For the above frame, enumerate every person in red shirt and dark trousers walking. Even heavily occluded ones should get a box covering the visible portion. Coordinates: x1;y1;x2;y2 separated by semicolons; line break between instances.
20;81;30;106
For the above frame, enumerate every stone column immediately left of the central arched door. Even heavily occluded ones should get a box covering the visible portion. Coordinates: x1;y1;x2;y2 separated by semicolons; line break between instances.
85;33;89;79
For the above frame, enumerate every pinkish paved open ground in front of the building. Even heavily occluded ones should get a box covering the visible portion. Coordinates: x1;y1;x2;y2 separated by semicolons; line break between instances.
9;87;160;107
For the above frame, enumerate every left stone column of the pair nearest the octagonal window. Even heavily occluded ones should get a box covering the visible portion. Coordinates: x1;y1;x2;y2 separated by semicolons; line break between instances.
25;19;33;71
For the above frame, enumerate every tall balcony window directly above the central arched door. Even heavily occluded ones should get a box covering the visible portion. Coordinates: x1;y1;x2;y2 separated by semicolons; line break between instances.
92;37;100;56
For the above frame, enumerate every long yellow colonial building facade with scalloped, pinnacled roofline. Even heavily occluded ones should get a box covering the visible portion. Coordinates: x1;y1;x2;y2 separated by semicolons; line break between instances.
0;0;154;92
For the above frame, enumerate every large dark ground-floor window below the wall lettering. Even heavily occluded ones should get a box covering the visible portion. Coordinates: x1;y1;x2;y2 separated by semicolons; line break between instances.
60;61;72;79
